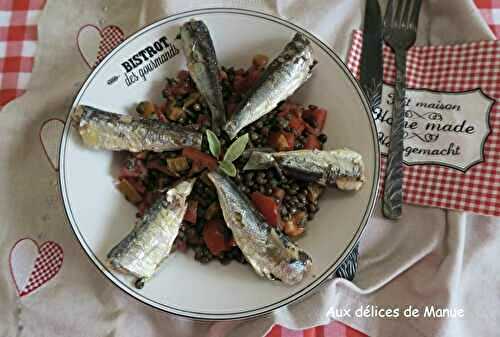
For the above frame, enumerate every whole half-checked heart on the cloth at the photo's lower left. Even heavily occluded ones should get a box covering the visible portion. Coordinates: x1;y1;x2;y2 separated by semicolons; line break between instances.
9;238;64;297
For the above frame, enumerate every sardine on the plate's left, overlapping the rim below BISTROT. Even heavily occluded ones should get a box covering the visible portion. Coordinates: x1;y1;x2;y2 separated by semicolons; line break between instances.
72;105;203;152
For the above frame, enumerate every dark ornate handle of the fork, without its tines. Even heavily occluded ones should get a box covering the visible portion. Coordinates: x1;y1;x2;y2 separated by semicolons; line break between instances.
382;50;406;219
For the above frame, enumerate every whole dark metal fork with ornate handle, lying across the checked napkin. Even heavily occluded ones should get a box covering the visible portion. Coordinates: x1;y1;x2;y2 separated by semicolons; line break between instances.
382;0;422;219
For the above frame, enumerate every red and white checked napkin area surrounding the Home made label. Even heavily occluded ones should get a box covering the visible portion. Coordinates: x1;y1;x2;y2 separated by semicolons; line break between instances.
348;31;500;216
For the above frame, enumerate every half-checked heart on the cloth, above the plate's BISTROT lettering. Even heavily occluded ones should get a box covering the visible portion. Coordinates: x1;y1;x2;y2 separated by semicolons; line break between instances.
76;24;124;68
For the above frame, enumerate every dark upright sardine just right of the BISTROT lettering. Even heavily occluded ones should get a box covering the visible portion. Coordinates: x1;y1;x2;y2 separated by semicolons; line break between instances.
180;20;226;130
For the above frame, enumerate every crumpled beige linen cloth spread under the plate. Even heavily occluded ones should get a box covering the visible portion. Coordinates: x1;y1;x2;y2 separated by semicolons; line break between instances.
0;0;500;337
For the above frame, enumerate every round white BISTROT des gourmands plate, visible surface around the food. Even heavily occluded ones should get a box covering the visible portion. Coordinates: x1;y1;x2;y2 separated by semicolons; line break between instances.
60;8;379;319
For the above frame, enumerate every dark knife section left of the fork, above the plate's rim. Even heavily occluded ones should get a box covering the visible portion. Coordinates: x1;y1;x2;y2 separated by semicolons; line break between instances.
360;0;384;111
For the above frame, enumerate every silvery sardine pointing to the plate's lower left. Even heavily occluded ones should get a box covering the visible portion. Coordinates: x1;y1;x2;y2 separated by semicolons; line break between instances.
108;178;196;280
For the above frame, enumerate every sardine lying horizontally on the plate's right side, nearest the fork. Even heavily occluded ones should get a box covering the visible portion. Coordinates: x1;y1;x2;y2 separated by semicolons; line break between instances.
243;149;365;191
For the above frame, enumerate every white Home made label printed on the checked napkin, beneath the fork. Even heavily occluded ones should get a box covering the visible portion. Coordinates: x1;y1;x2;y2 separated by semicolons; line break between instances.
373;84;495;172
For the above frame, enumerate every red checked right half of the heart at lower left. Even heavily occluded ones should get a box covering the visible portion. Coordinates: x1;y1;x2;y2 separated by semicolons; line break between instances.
19;241;64;297
